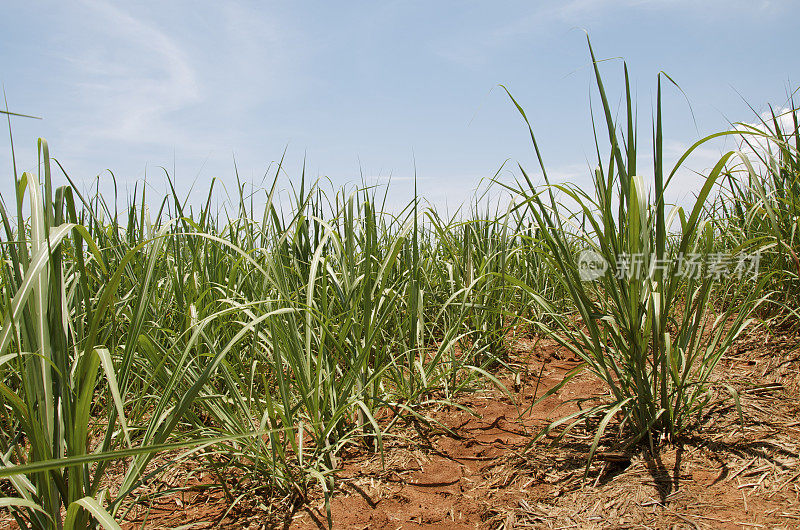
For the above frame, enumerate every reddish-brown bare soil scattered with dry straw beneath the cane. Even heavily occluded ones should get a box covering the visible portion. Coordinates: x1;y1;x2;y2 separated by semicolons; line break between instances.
1;324;800;529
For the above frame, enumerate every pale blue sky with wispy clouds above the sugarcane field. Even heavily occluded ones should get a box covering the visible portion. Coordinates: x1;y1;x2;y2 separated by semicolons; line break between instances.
0;0;800;210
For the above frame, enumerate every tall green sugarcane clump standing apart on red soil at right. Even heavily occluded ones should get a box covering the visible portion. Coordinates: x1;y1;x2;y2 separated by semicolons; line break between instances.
500;39;763;464
